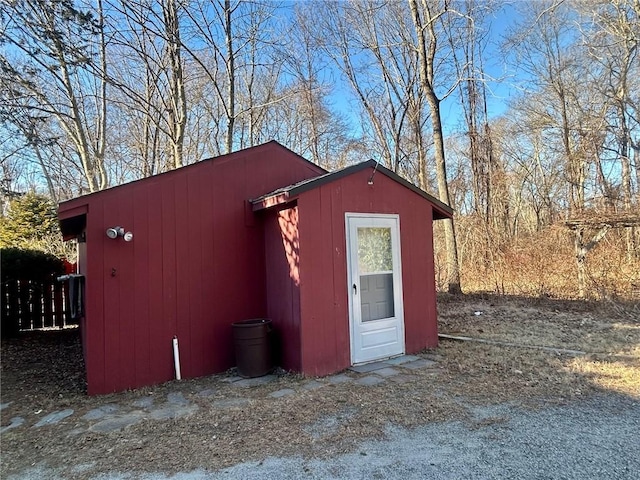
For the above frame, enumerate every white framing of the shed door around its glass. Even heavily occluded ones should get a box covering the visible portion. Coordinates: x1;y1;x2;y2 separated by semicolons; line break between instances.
345;212;405;365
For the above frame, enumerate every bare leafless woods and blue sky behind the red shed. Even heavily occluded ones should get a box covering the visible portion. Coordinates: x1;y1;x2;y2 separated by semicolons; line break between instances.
0;0;640;299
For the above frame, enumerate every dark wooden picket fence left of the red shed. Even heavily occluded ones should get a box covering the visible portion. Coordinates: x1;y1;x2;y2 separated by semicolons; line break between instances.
2;280;78;332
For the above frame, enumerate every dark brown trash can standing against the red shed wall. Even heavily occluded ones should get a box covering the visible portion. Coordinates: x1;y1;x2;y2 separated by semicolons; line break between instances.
231;318;273;378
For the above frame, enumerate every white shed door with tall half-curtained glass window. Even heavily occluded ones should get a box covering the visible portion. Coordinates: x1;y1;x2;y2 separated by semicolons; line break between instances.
346;213;404;364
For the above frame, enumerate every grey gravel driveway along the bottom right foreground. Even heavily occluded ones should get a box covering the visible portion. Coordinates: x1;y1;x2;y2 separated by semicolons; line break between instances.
7;393;640;480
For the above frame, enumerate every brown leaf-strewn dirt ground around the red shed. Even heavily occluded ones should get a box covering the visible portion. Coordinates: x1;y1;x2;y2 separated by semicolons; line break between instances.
0;295;640;478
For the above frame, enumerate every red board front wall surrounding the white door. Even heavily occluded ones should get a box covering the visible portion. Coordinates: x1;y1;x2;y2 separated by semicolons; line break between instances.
298;170;437;375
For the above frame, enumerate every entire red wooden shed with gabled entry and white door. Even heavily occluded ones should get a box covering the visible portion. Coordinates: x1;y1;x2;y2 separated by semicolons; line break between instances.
59;142;452;394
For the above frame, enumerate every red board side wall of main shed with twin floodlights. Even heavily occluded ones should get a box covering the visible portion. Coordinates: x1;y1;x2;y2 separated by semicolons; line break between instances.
60;143;323;394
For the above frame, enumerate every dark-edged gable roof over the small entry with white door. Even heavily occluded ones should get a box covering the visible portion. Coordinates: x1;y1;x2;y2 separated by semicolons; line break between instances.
250;160;453;220
